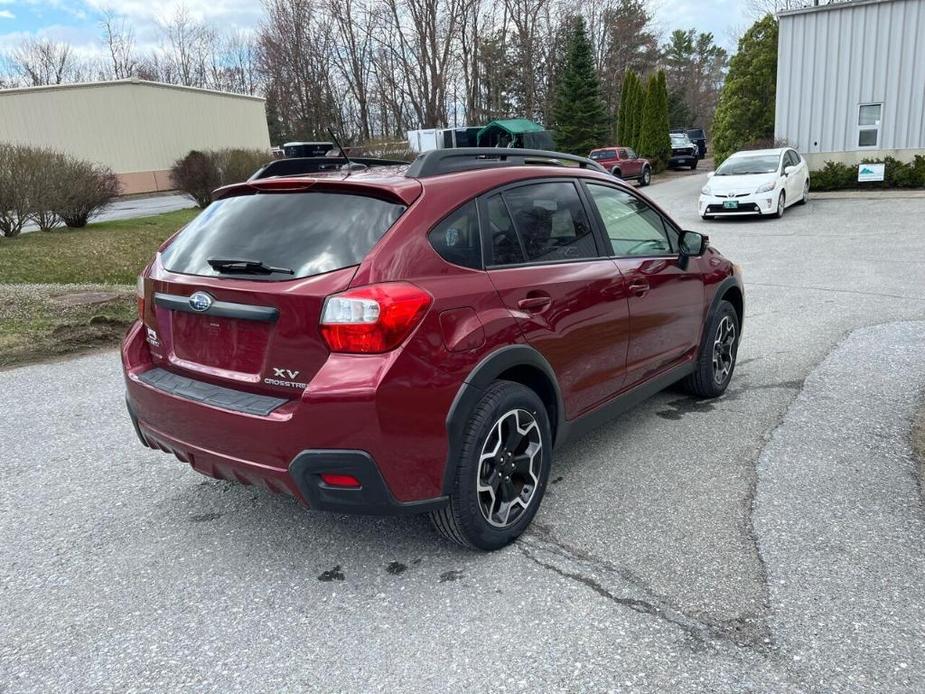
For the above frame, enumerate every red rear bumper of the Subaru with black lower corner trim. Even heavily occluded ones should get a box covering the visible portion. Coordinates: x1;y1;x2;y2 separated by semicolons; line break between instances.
122;324;459;514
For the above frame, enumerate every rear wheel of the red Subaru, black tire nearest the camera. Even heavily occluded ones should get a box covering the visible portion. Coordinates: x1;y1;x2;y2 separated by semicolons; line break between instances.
430;381;552;551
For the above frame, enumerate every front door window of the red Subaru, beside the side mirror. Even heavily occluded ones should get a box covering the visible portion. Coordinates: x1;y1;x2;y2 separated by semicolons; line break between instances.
588;183;677;256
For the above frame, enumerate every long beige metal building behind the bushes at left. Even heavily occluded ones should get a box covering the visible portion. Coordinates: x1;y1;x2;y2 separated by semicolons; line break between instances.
0;79;270;194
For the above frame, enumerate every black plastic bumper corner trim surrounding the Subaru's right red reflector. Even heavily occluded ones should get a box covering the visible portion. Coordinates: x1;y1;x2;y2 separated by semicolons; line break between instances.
289;450;448;516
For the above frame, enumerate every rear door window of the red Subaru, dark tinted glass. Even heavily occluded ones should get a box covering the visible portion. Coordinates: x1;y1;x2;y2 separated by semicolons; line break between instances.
504;181;598;263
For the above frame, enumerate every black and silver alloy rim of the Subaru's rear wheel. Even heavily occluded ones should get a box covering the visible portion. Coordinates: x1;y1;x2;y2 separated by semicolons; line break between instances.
476;410;543;528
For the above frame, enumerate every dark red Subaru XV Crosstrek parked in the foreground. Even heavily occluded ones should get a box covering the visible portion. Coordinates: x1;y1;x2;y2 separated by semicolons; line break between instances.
122;149;743;550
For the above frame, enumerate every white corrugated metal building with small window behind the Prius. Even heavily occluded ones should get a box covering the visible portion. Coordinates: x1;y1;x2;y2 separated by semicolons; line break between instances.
775;0;925;169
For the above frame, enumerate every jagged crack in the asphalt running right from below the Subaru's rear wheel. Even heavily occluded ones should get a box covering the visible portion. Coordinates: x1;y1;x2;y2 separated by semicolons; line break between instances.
516;521;776;660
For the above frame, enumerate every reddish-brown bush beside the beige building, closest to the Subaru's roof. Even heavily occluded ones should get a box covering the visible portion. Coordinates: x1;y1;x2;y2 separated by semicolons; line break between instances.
170;148;273;207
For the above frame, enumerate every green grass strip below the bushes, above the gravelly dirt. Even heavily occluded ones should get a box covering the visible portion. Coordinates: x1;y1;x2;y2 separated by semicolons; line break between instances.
0;210;198;285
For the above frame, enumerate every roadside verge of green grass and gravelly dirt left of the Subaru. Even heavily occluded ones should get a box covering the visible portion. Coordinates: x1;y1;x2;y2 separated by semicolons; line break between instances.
0;210;198;368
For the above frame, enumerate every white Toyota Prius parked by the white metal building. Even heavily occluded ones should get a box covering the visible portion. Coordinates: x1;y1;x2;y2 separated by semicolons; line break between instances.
699;147;809;219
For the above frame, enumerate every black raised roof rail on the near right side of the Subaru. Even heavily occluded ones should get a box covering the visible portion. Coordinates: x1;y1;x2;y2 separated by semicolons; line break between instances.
405;147;607;178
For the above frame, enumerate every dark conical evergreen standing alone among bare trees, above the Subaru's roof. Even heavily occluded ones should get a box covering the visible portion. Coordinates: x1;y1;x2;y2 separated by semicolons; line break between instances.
554;16;609;155
